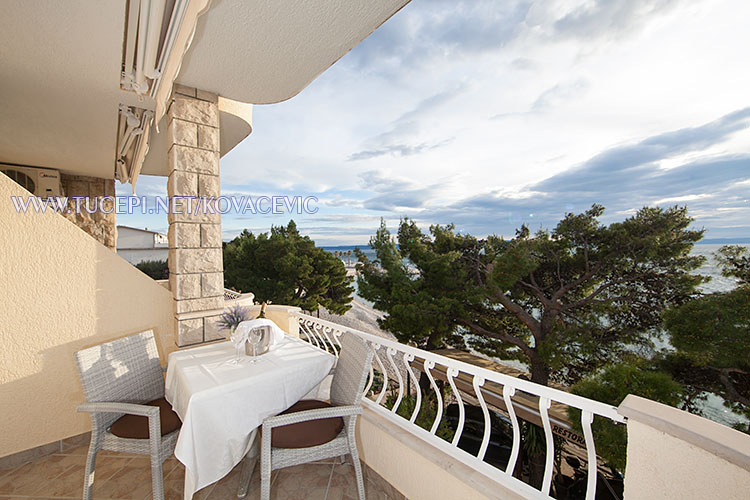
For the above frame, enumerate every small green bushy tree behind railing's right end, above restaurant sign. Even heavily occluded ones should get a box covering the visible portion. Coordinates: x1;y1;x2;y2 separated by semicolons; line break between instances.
568;360;682;471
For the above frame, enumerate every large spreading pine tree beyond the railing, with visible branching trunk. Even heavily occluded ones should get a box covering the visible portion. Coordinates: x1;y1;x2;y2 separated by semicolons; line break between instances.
357;205;705;385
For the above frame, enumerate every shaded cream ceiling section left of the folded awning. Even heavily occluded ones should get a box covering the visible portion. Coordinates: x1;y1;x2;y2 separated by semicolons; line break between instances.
0;0;129;178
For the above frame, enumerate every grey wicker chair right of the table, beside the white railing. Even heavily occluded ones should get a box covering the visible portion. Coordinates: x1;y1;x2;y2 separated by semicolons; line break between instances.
260;333;373;500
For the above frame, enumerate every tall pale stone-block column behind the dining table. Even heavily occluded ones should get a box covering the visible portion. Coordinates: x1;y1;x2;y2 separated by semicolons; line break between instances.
167;86;224;347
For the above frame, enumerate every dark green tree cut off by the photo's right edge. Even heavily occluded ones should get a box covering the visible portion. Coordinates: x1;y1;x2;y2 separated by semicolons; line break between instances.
663;246;750;416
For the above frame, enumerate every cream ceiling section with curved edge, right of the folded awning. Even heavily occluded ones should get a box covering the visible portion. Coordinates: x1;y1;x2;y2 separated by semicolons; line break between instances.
178;0;409;104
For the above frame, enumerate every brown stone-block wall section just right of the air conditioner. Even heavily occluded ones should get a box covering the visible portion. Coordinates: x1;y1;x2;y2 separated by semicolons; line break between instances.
60;174;117;251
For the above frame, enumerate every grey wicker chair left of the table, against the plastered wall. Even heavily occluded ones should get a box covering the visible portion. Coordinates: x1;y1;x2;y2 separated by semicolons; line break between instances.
75;330;180;500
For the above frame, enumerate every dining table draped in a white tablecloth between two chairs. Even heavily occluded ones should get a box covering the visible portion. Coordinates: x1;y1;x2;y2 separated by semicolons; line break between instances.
165;335;335;500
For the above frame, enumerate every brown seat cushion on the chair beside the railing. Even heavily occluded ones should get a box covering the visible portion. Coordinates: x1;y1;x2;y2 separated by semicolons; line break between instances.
271;399;344;448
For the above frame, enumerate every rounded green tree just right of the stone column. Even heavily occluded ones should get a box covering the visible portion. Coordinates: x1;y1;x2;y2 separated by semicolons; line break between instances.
224;221;354;314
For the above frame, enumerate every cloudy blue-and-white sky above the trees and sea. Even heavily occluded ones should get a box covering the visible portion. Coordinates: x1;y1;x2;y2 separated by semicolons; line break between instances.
118;0;750;245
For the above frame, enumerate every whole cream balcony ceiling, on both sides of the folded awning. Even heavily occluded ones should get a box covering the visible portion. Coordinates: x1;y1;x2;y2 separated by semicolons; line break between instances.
0;0;408;178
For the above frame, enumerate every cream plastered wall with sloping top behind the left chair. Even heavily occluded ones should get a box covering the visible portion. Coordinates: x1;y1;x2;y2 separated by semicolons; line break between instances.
0;174;175;457
